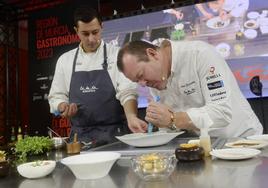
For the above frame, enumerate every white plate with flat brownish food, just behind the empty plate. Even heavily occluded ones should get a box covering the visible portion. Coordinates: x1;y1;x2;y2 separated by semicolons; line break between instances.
225;140;268;149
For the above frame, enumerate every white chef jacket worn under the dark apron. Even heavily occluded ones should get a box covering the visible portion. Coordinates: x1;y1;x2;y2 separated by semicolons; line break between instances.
48;41;138;113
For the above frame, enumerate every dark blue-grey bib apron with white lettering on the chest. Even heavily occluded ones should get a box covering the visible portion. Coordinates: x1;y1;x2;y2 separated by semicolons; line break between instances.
69;44;128;144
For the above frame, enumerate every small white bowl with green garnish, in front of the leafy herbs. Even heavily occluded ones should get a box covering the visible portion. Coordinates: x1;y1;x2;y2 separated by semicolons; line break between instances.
17;160;56;179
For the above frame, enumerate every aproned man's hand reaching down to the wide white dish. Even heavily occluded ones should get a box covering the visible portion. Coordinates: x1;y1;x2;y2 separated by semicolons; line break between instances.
127;114;147;133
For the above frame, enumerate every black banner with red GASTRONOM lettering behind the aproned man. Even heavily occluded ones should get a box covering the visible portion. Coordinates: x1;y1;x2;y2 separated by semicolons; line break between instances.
28;2;79;136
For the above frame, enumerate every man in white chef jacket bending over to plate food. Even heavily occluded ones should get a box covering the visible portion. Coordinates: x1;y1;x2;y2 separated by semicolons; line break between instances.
117;40;263;137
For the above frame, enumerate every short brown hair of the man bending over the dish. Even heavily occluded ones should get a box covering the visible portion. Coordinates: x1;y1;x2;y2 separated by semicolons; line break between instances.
117;40;158;72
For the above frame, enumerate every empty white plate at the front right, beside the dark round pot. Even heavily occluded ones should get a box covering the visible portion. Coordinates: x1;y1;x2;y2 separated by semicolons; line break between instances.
210;148;261;160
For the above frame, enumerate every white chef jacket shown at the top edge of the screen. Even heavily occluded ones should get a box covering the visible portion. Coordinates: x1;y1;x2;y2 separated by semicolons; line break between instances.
222;0;249;17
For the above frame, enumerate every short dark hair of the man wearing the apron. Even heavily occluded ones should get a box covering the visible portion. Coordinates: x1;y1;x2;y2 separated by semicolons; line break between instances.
74;5;102;27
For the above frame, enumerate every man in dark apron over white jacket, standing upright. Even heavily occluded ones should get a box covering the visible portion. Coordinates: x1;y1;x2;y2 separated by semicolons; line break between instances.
48;6;147;143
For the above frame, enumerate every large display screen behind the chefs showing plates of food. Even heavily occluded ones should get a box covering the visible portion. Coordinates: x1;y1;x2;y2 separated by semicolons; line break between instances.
103;0;268;108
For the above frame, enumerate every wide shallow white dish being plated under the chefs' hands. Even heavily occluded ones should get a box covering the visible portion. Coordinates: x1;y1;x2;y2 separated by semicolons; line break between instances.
116;131;184;147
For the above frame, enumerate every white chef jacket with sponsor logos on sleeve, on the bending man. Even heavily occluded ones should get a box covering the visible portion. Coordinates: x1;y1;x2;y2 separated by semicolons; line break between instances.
151;41;263;137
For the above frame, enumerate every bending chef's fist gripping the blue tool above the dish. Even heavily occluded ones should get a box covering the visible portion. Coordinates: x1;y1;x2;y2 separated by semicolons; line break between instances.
145;101;171;128
